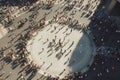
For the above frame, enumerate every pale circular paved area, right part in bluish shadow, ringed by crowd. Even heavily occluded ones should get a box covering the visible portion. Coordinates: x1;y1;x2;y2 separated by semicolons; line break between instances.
27;23;95;78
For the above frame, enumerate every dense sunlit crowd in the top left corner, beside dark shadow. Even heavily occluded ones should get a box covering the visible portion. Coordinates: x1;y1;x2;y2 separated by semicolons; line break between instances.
0;0;30;27
